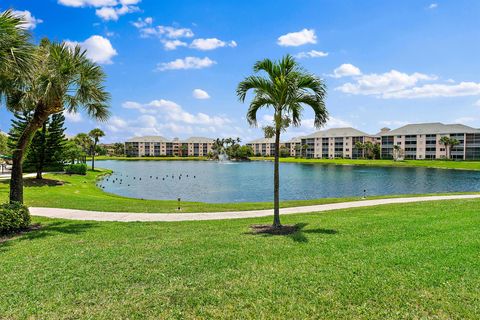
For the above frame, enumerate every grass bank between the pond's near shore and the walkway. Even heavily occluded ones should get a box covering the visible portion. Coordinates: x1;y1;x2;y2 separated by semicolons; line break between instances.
0;170;473;213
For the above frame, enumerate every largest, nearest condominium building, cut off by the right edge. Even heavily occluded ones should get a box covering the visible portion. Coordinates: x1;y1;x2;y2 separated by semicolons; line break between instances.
377;122;480;160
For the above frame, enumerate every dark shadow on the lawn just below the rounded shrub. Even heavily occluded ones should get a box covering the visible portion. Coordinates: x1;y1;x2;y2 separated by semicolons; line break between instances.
0;221;97;253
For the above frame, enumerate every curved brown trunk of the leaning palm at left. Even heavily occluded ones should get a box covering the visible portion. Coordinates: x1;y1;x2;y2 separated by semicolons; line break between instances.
10;106;48;203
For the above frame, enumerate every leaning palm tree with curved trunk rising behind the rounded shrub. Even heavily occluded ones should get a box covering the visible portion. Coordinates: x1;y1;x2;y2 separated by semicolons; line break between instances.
7;39;110;202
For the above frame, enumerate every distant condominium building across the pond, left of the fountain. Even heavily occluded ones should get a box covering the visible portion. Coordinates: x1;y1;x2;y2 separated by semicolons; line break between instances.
125;136;214;157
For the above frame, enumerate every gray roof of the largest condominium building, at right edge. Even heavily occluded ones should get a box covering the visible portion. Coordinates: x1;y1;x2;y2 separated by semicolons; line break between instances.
378;122;480;136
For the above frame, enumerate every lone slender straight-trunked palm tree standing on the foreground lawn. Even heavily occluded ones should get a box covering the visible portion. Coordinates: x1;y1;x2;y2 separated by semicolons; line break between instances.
237;55;328;228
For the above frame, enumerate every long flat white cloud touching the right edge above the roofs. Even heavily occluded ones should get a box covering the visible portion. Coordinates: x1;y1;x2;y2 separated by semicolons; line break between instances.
383;82;480;99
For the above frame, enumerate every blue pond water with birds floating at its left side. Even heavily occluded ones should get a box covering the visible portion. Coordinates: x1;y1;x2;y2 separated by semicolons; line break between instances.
98;160;480;203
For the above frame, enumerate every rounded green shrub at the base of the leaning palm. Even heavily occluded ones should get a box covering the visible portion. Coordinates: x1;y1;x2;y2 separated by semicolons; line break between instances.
0;202;30;235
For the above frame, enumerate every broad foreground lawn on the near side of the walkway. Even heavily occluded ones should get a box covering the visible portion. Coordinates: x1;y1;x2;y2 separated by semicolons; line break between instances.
0;200;480;319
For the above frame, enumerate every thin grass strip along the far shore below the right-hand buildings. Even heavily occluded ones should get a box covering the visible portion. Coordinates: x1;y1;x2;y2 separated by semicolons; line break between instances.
250;157;480;170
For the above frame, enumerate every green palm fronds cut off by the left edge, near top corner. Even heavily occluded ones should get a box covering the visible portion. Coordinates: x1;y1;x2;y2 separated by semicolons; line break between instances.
0;10;35;104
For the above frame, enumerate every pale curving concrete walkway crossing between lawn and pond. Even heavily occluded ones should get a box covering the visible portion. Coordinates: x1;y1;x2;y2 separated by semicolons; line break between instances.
30;194;480;222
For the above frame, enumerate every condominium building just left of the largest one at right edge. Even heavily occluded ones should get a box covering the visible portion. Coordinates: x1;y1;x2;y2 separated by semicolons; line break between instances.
301;127;376;159
